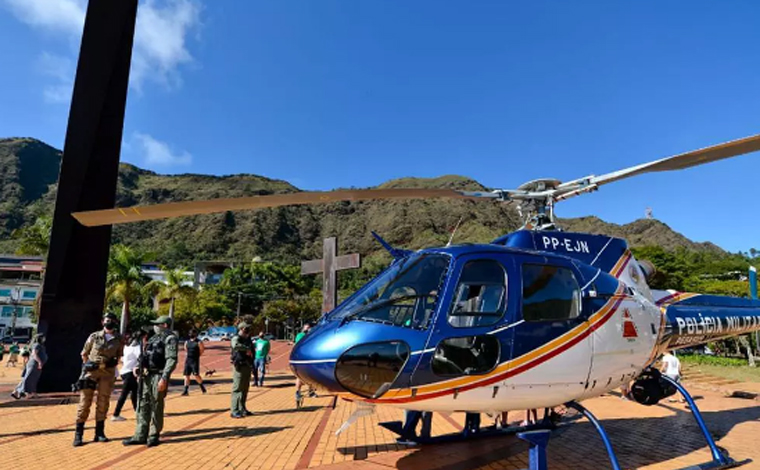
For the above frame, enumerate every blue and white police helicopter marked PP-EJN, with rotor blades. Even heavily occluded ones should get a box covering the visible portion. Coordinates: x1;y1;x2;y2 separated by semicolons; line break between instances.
74;135;760;468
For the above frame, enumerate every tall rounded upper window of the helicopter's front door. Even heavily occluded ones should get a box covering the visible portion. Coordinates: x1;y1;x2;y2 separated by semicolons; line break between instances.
449;259;507;328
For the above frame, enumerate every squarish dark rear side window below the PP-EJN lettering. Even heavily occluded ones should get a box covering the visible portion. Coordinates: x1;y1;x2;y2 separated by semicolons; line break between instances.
522;264;581;321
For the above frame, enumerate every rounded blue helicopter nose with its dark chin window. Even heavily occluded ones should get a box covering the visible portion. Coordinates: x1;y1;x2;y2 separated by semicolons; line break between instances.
290;328;410;398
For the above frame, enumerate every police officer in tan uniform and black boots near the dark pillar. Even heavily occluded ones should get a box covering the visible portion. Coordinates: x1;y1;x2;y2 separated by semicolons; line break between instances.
74;313;124;447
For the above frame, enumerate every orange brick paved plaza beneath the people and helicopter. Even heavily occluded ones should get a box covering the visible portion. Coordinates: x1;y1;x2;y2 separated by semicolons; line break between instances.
0;343;760;470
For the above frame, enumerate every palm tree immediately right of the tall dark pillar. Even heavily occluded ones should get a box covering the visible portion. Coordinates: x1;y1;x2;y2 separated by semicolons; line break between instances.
106;245;148;332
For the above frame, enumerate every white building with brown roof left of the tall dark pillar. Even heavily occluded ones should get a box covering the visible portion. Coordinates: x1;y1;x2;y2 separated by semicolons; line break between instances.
0;255;45;338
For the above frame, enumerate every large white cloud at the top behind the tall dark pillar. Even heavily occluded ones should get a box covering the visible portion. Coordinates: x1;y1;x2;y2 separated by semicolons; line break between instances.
0;0;201;97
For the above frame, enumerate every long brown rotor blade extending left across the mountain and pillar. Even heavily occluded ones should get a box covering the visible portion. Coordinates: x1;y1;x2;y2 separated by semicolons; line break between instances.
73;188;486;227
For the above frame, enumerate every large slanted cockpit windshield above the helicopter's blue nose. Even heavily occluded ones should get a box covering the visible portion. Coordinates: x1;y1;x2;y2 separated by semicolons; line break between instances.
330;253;450;328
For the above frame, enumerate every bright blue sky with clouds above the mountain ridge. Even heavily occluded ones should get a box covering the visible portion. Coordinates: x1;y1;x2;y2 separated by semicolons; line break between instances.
0;0;760;251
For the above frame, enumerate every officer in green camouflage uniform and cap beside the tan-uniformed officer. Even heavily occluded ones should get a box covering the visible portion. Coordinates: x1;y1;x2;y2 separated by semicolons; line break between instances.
122;315;178;447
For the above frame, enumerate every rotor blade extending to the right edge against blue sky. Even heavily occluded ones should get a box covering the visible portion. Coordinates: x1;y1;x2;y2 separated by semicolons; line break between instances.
589;134;760;185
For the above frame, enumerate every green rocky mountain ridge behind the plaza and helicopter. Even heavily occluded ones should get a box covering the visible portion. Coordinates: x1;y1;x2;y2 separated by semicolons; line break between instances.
0;138;723;264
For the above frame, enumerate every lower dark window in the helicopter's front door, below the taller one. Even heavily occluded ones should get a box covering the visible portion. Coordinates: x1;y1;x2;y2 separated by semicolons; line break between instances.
432;335;499;376
